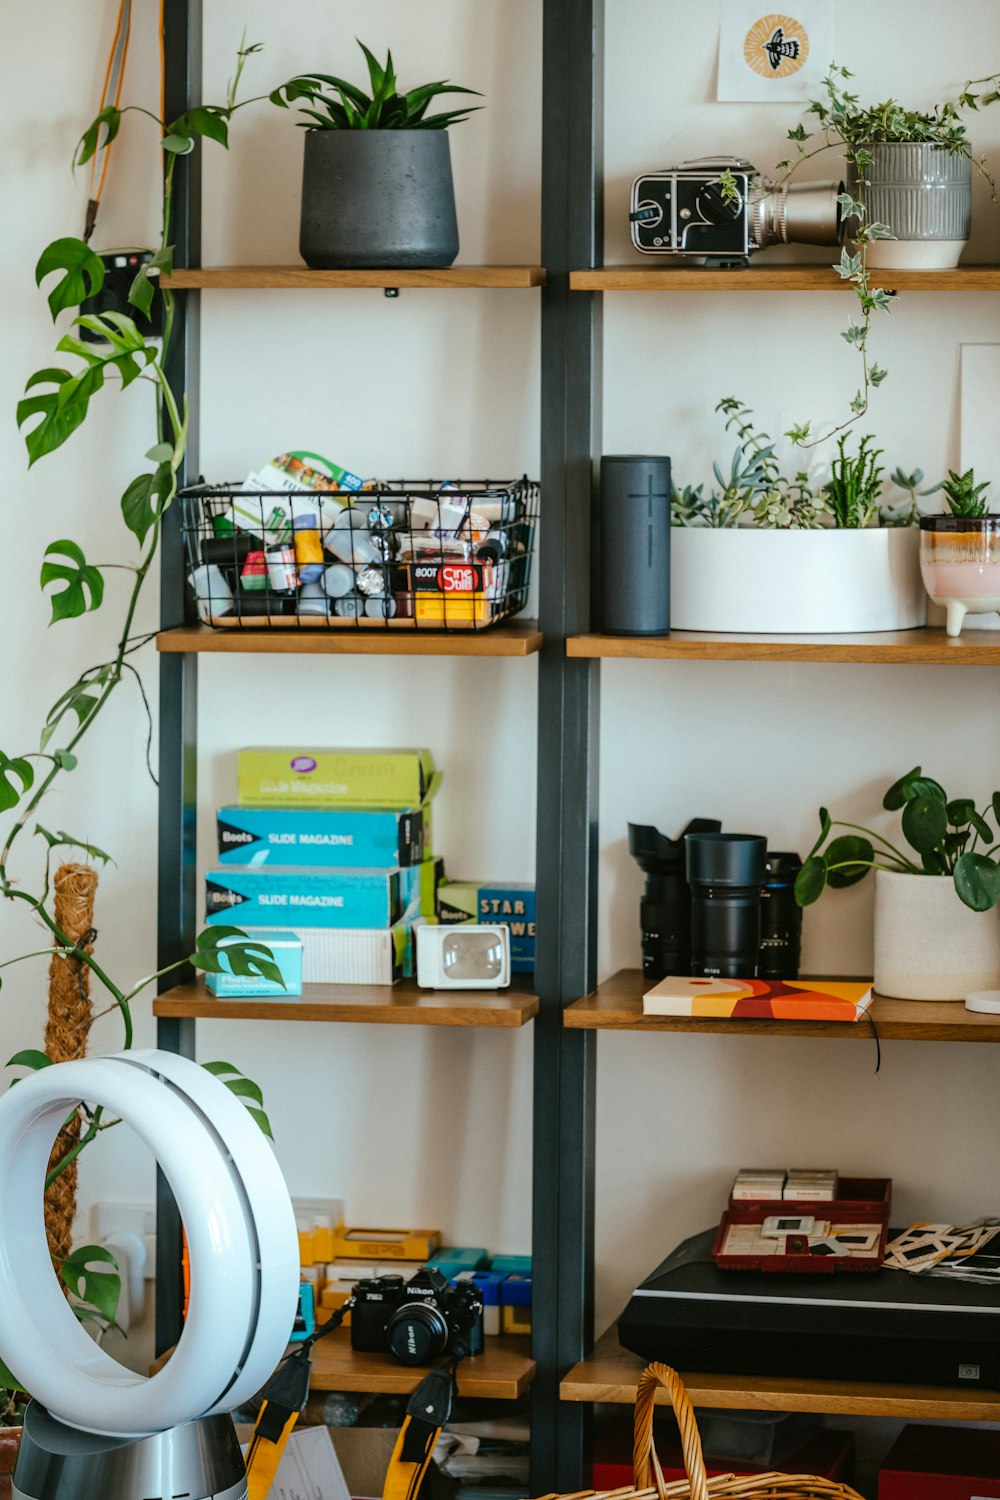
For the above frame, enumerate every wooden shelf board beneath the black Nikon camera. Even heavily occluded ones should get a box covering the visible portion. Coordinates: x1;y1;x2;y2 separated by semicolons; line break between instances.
309;1329;535;1401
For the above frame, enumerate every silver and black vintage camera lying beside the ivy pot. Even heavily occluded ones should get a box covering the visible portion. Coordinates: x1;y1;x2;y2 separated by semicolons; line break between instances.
628;156;844;266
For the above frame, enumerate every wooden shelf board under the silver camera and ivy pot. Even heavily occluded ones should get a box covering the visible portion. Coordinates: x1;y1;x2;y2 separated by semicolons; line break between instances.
570;264;1000;291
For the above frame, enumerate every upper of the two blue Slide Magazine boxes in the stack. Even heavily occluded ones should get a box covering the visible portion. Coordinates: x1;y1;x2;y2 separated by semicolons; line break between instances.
216;807;427;870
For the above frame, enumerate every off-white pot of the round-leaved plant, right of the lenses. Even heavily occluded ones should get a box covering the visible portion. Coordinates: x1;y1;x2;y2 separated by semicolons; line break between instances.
876;870;1000;1001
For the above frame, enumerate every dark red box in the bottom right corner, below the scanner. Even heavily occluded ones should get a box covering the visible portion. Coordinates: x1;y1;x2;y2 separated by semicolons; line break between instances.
879;1427;1000;1500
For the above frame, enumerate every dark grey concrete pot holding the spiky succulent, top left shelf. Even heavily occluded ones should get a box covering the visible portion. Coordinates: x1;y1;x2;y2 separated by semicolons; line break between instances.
298;131;459;270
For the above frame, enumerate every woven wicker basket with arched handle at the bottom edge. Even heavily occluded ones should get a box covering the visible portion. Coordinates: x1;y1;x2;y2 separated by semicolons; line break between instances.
544;1365;862;1500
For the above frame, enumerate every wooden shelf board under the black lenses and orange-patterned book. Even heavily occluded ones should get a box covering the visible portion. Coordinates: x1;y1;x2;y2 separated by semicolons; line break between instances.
562;969;1000;1041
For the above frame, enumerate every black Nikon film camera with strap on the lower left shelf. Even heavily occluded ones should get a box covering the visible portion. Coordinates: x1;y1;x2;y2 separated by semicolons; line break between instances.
351;1266;483;1365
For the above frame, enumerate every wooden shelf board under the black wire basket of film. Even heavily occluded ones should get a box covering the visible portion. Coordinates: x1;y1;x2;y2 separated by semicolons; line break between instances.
156;620;541;657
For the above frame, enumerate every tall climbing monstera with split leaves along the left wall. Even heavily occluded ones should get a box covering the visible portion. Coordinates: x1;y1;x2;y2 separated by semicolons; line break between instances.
0;38;280;1421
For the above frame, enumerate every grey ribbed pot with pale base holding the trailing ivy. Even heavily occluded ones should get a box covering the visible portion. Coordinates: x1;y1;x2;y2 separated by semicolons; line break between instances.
849;143;972;270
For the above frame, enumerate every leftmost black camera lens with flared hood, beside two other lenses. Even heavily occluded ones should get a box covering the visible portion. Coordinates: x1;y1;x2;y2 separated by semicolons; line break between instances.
628;818;723;983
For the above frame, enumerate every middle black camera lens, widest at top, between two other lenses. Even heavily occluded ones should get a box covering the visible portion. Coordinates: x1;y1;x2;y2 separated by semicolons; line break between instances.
684;834;768;980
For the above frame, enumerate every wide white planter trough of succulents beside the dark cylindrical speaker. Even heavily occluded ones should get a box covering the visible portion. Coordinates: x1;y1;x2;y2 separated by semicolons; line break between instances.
670;527;927;635
